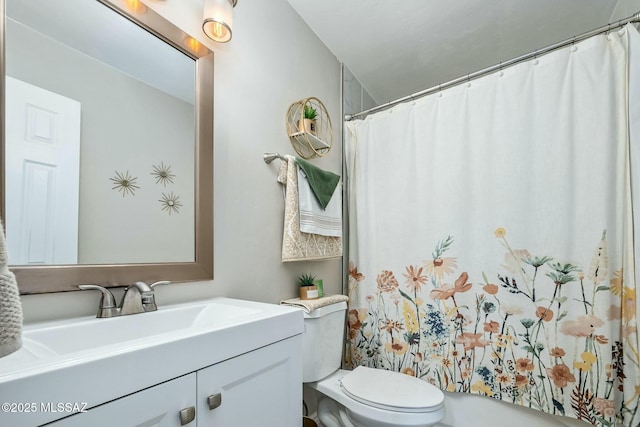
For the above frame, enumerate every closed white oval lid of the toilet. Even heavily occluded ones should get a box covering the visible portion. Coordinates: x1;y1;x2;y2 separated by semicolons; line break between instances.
340;366;444;412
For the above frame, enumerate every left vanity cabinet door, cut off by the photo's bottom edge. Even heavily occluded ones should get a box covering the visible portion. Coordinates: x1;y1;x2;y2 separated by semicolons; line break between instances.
47;373;197;427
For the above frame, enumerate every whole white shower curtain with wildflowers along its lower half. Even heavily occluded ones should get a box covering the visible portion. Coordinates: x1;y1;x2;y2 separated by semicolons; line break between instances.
345;25;640;426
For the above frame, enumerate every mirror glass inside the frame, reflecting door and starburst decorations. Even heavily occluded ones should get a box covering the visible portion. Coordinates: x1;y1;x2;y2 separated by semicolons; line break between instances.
5;0;195;265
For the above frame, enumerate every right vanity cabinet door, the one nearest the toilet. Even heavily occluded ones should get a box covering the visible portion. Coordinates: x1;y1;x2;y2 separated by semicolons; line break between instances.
197;335;302;427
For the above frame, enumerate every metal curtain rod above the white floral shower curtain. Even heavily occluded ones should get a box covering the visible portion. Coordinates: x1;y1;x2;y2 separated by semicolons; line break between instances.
344;12;640;121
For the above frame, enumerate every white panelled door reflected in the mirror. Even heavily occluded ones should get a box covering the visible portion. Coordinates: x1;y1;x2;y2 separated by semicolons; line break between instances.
5;77;80;265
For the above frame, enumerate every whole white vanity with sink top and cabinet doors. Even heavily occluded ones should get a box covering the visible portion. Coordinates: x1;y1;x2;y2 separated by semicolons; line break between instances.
0;298;304;427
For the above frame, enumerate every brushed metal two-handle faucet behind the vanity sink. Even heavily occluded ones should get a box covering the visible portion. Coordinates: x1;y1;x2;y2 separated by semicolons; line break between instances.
78;280;171;317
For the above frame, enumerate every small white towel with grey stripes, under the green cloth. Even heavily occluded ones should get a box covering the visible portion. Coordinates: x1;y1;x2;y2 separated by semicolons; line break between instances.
297;166;342;237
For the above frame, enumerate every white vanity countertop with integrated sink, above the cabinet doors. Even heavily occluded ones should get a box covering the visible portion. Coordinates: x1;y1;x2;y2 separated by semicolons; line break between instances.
0;298;304;427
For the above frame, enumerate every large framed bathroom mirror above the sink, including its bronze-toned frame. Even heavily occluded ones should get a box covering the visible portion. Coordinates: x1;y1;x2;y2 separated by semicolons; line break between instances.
0;0;213;294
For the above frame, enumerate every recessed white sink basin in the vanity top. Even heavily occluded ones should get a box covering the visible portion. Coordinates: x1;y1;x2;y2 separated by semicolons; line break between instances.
23;301;258;355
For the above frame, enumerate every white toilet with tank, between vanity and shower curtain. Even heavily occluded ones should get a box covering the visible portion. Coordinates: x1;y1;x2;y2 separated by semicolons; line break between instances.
302;302;445;427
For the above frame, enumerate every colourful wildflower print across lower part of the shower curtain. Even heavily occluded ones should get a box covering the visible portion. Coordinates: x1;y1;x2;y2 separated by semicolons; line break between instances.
348;228;640;426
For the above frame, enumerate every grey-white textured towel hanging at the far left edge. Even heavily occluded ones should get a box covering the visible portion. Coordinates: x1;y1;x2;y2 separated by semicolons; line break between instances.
0;220;22;357
